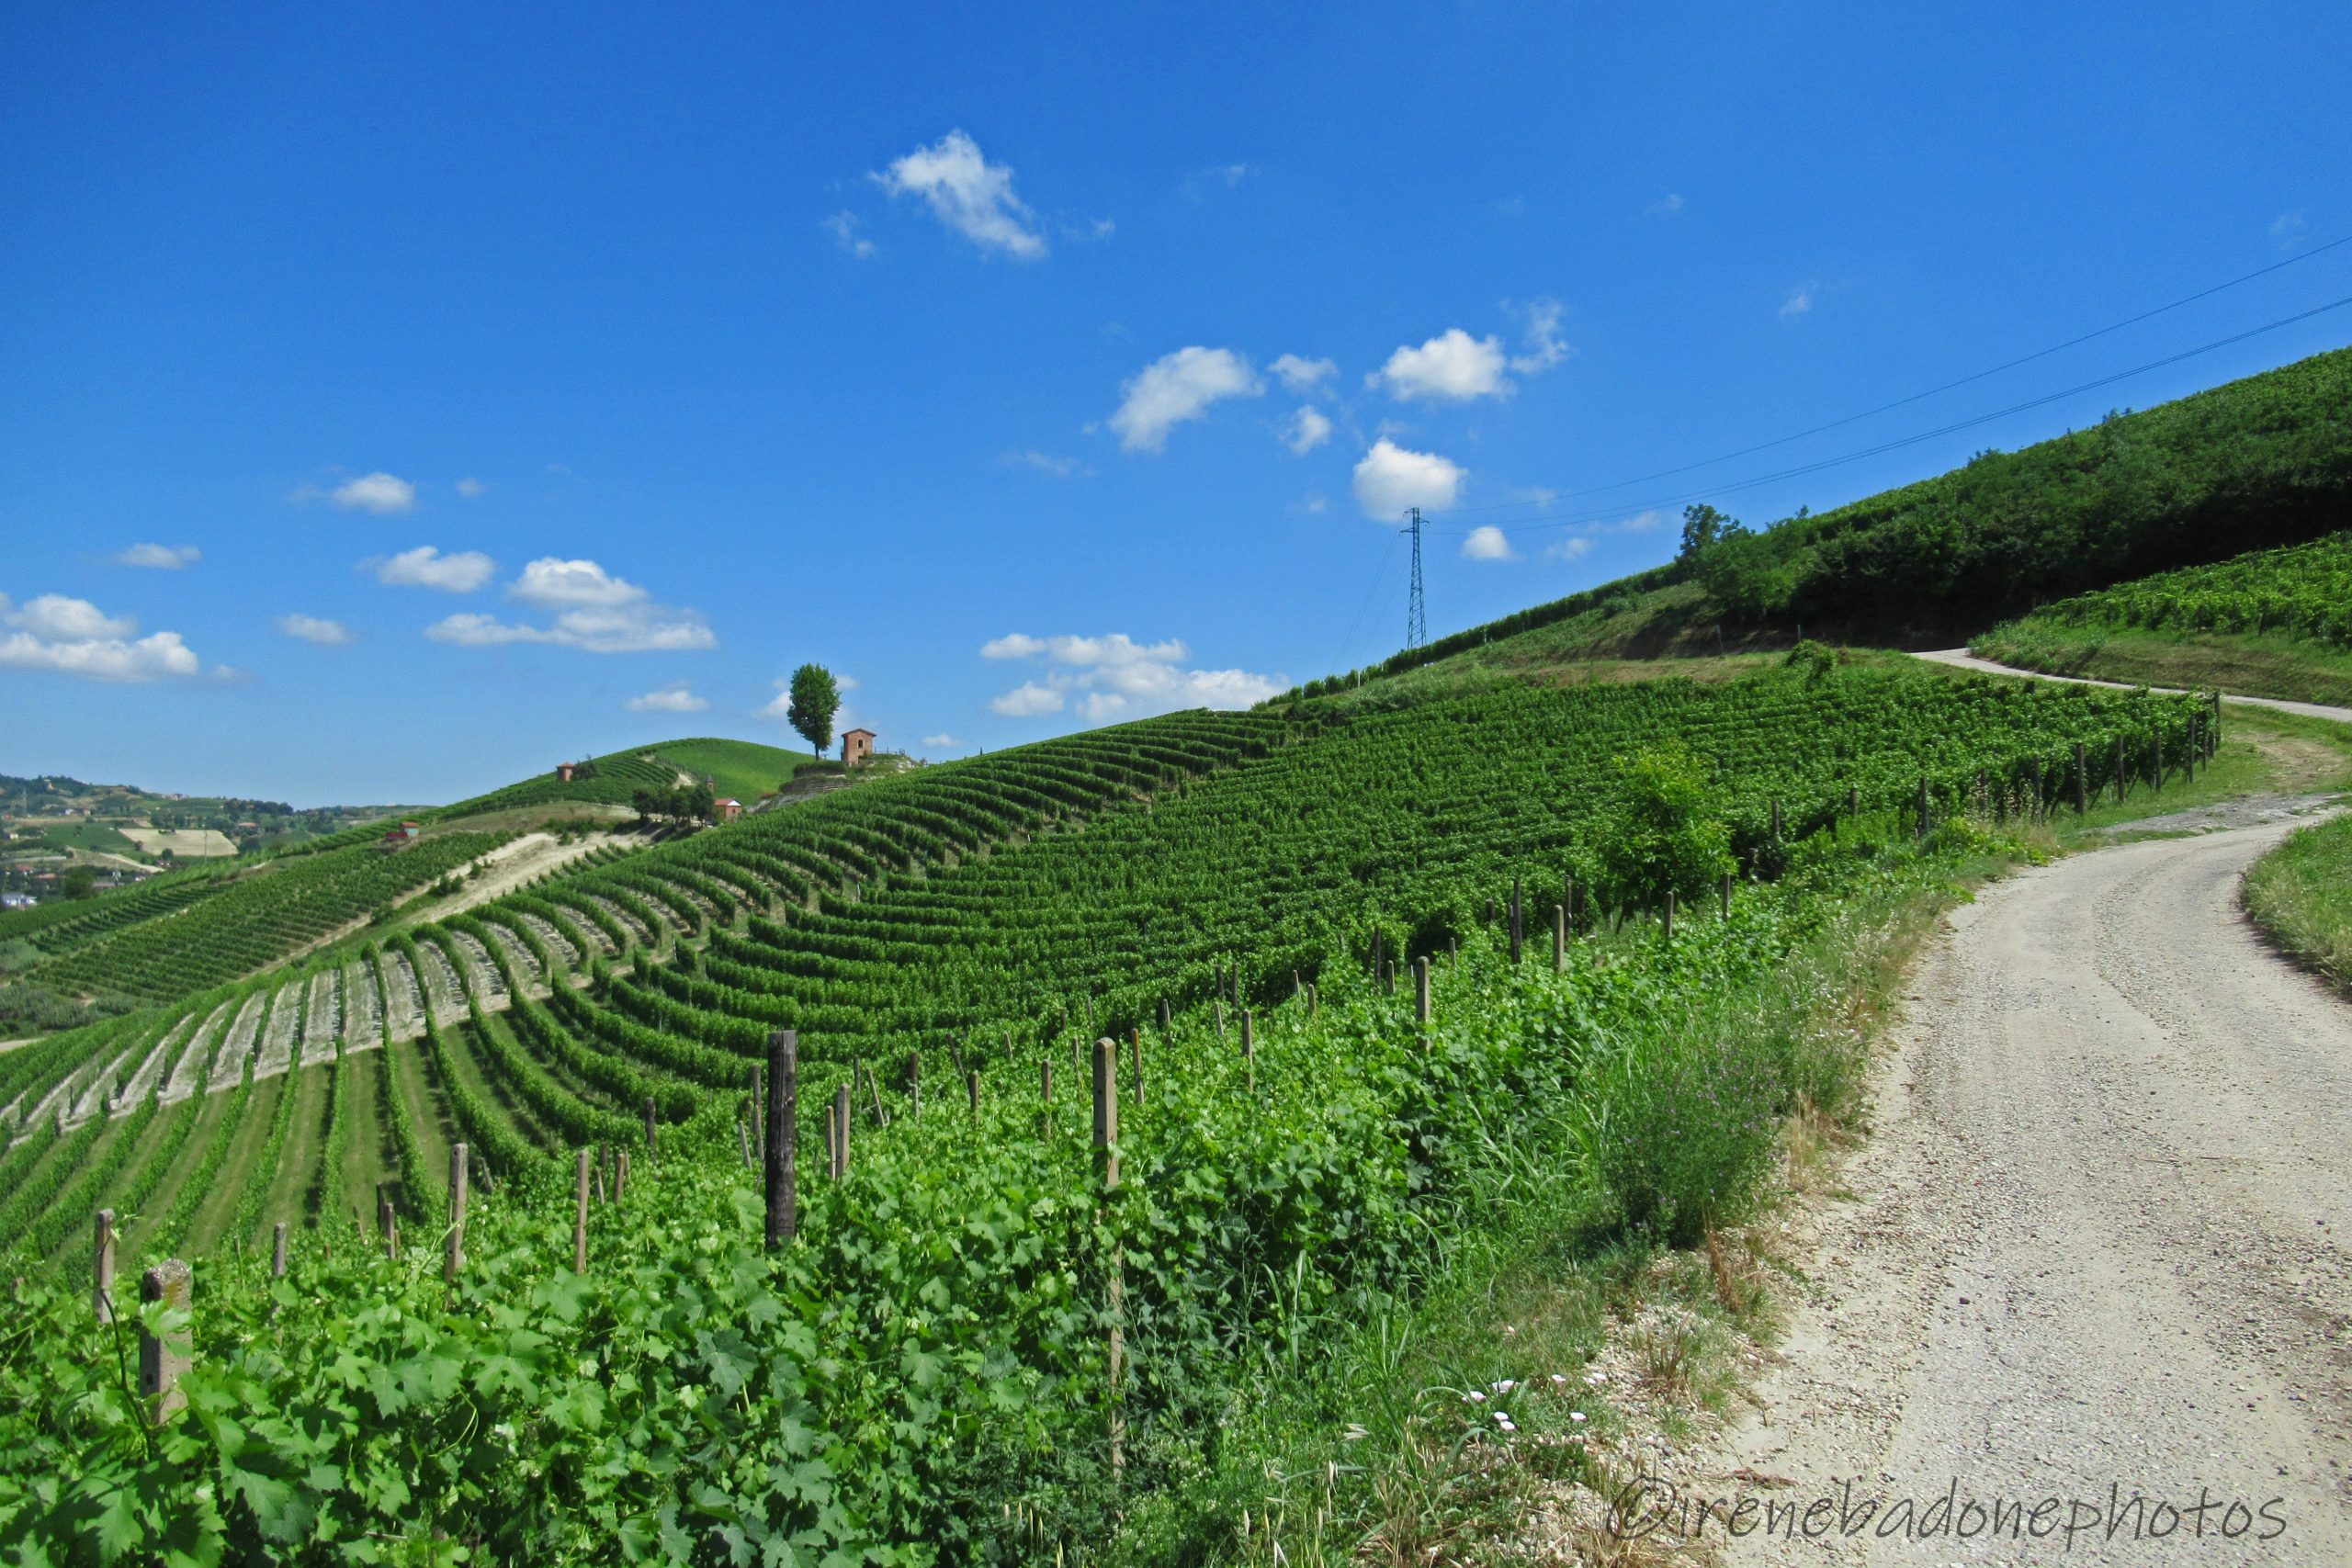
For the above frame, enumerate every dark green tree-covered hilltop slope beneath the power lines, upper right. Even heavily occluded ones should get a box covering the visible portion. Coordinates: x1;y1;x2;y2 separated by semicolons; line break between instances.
1307;348;2352;691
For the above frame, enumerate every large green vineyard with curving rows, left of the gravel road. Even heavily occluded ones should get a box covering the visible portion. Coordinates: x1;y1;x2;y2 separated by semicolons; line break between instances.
0;659;2218;1563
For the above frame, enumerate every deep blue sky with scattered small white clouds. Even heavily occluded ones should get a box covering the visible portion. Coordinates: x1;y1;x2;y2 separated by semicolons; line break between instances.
0;5;2352;804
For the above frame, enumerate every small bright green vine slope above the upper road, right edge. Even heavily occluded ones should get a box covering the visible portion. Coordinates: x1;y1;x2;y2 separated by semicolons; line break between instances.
1971;534;2352;703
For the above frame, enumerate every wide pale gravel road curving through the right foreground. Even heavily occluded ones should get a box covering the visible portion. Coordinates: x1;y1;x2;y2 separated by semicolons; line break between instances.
1714;823;2352;1563
